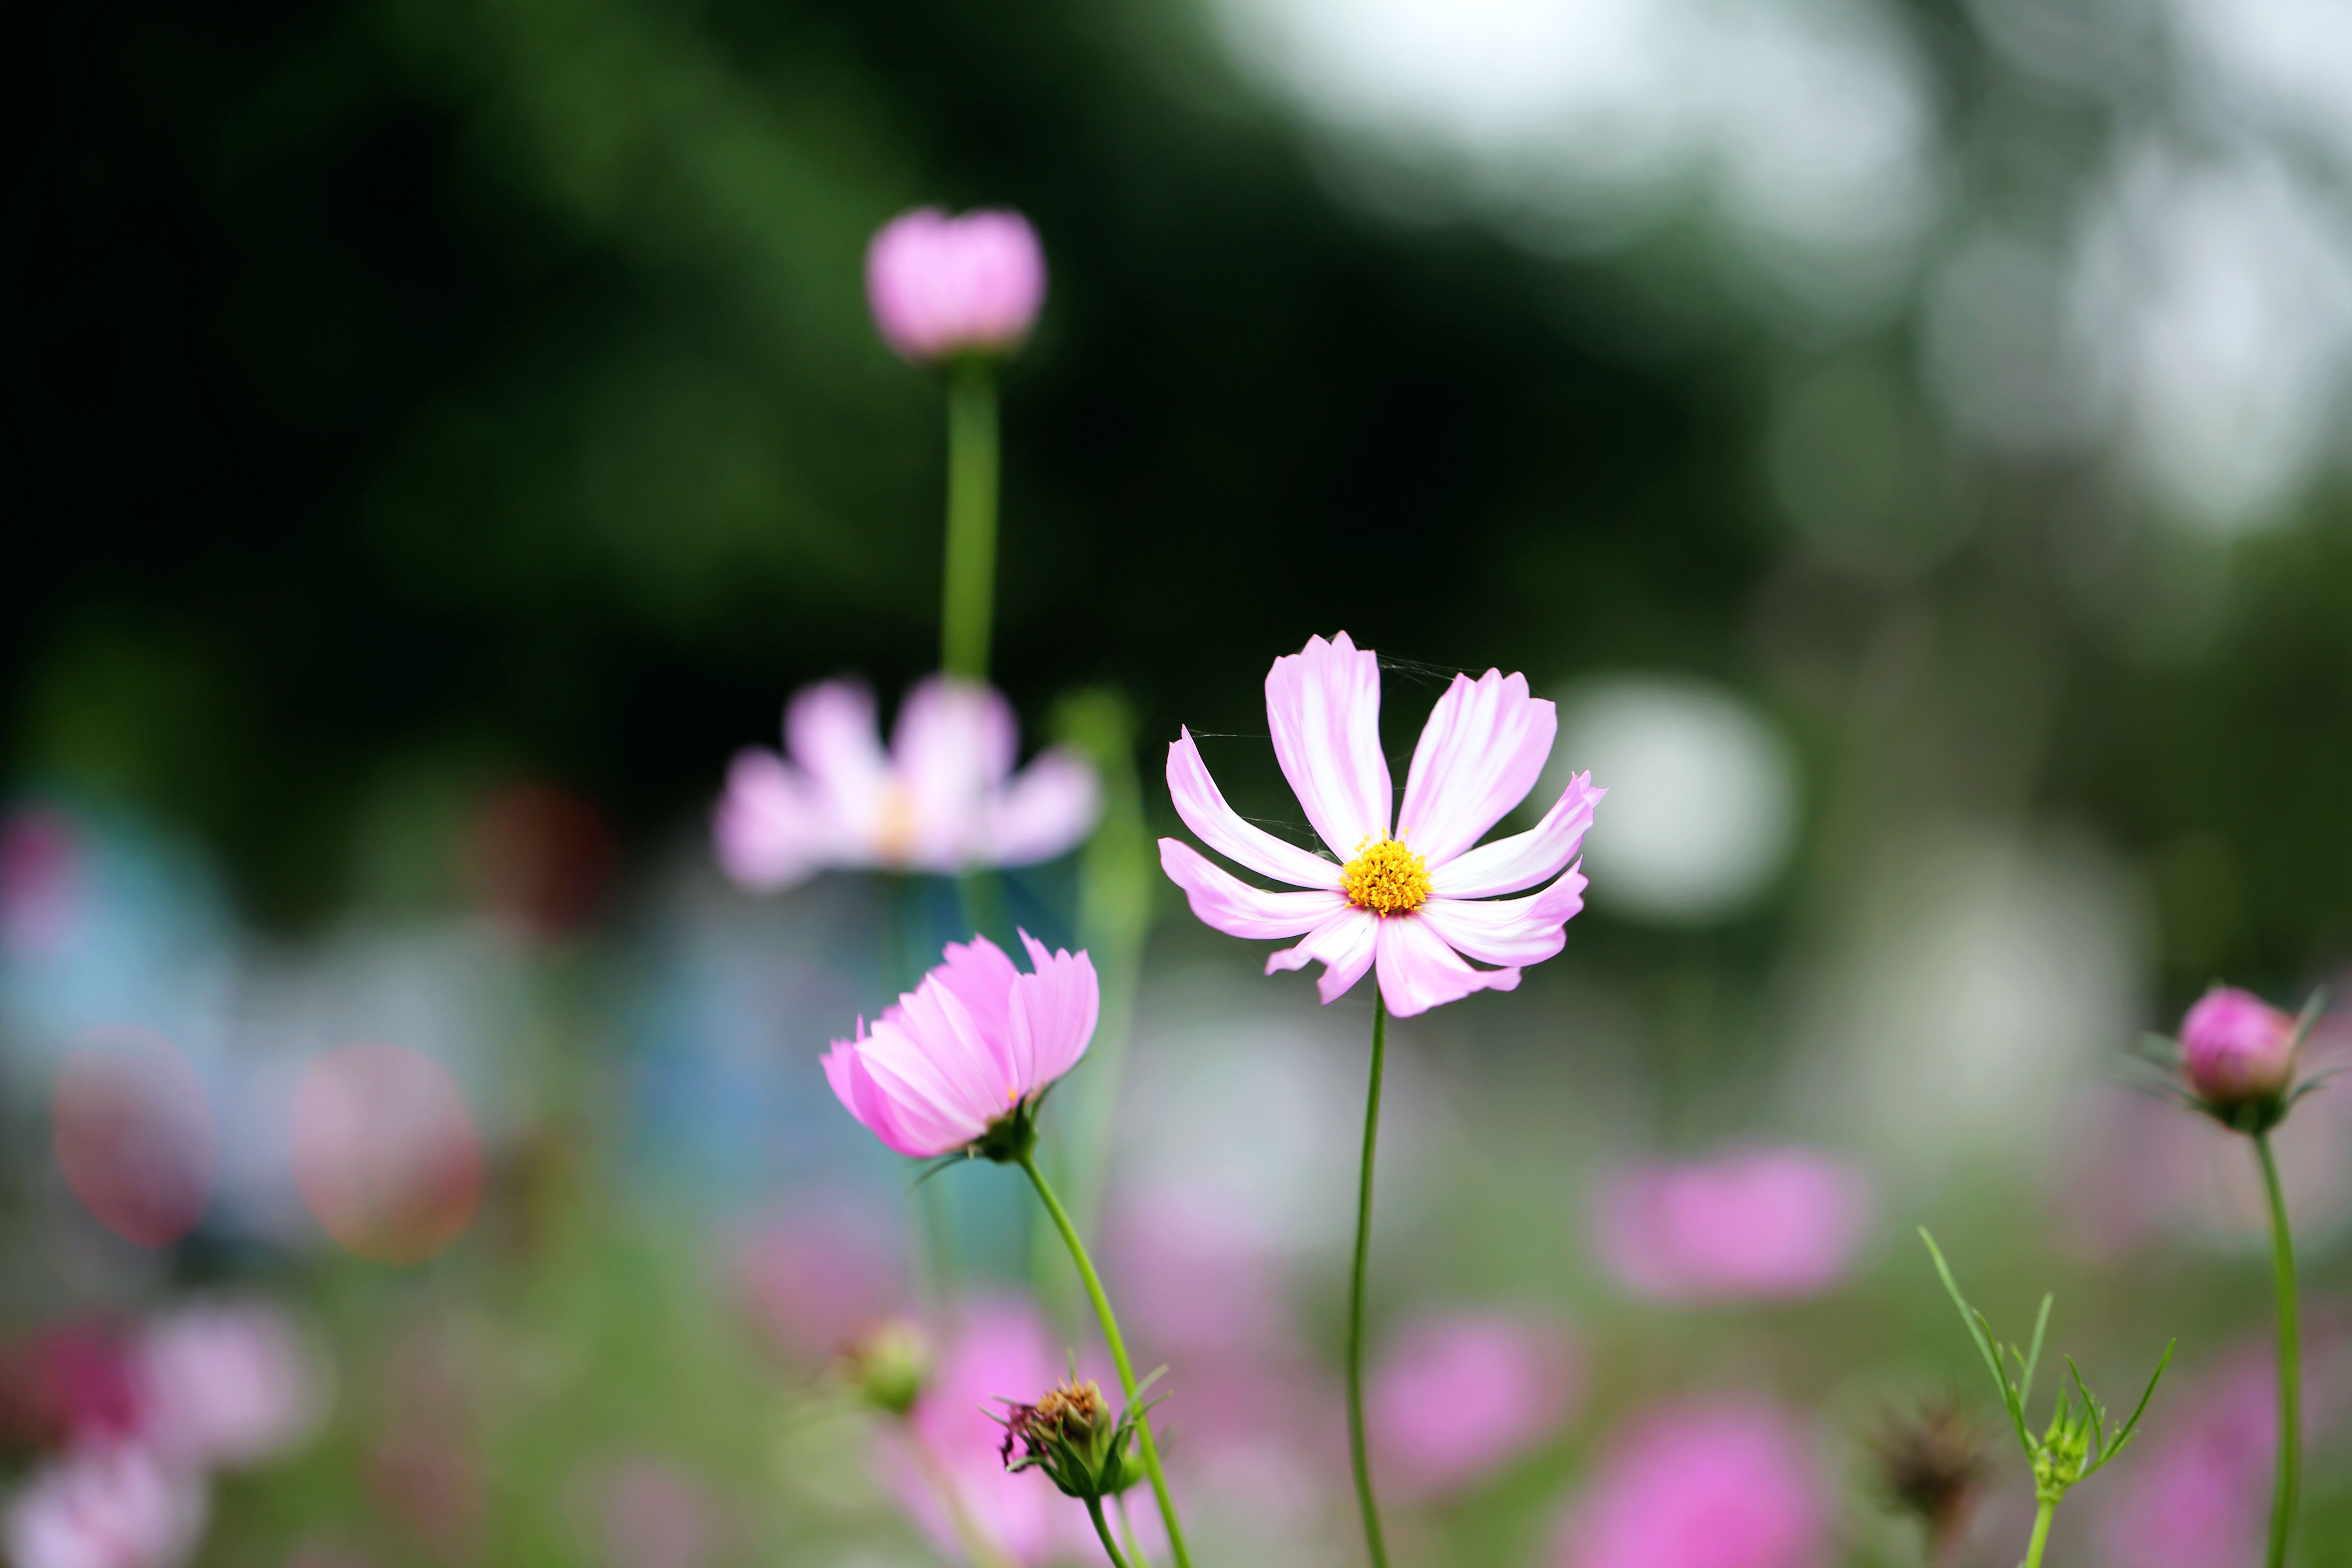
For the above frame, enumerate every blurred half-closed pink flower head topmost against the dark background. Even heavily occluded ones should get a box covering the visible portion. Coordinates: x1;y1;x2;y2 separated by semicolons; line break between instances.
866;207;1044;362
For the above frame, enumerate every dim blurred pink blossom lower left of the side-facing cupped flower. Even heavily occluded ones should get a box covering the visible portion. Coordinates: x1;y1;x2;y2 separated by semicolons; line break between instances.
734;1201;906;1363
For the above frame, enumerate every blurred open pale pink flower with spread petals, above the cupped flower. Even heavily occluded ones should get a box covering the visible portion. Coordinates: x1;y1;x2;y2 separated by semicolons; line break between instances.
713;675;1098;891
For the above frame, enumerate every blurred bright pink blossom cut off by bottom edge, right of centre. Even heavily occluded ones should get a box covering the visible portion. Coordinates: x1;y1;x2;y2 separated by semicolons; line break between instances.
1555;1403;1832;1568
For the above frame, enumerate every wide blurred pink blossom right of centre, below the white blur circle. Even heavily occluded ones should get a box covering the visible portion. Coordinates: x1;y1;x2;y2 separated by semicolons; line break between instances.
1595;1147;1870;1300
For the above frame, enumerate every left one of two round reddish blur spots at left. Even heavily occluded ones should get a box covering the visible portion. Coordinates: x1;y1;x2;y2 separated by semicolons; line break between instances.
49;1027;214;1246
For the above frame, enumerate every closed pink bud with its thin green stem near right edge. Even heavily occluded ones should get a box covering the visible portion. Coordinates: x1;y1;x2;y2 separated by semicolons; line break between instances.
2140;985;2343;1568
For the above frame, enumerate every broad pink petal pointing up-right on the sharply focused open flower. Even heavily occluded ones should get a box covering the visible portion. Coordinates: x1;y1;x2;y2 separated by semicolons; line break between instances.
1397;670;1559;865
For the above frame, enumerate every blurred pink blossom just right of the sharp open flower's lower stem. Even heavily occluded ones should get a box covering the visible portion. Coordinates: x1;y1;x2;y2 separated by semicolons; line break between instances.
1371;1312;1573;1497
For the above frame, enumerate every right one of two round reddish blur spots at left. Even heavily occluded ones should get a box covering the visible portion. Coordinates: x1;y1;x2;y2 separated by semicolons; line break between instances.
294;1046;482;1263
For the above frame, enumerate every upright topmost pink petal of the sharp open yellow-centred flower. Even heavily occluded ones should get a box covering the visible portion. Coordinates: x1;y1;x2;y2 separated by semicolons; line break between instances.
1265;633;1395;860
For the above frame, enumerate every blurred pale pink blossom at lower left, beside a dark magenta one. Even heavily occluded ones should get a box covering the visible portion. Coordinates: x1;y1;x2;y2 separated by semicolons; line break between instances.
141;1300;327;1469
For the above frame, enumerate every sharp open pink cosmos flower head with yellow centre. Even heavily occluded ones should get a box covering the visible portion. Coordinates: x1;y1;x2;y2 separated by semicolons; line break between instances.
1160;633;1602;1018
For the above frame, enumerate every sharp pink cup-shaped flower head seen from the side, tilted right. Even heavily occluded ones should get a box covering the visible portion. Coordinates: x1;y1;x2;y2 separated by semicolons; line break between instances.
826;931;1103;1159
